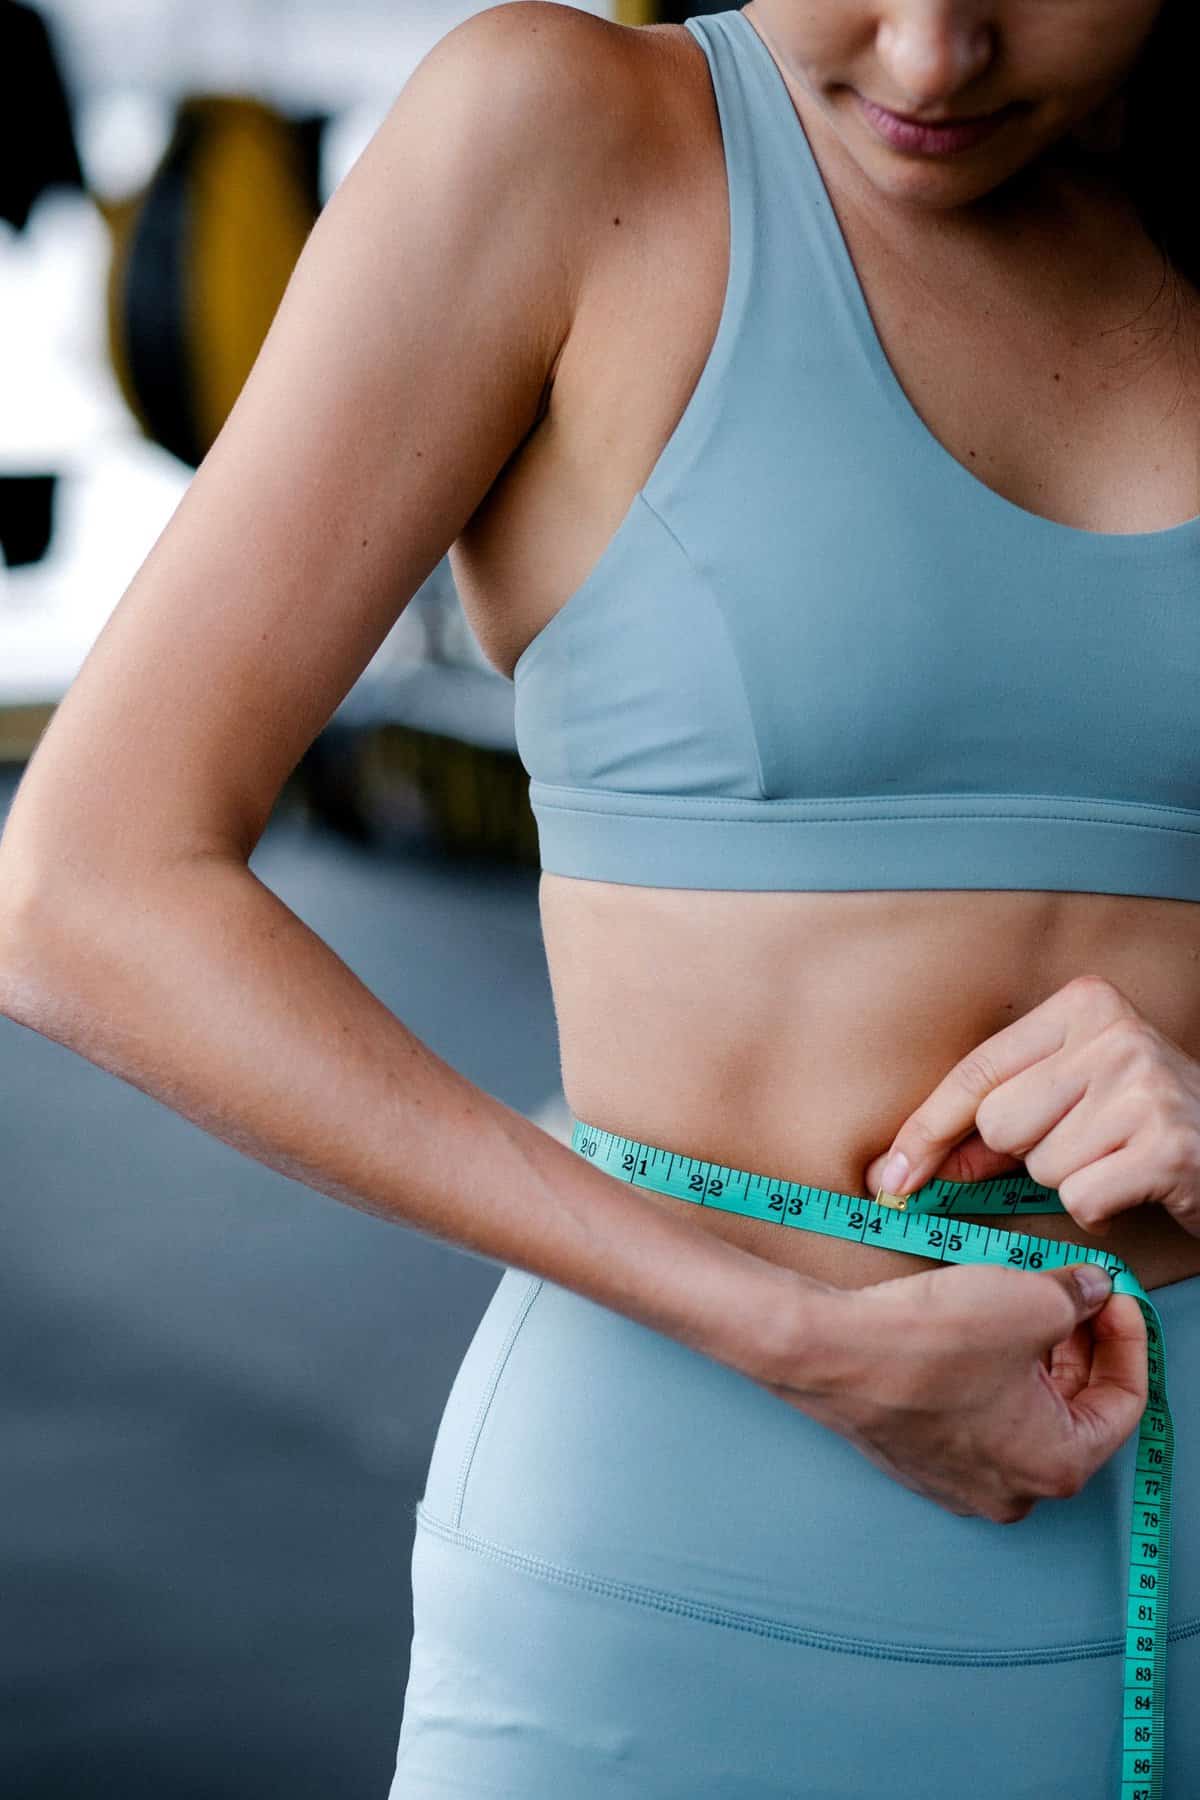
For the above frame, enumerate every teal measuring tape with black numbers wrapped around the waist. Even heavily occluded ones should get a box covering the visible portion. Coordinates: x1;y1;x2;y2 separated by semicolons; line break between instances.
570;1120;1175;1800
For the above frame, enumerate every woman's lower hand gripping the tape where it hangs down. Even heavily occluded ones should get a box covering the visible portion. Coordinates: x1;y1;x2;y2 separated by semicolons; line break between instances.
759;1264;1148;1525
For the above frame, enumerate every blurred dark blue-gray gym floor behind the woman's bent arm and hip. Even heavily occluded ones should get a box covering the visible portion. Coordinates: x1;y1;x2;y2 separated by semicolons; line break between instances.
0;779;558;1800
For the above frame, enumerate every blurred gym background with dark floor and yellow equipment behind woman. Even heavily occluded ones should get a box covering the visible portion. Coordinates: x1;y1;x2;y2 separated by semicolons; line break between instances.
0;0;720;1800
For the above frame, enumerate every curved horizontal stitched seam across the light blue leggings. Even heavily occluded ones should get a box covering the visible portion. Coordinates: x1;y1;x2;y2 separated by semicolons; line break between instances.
416;1503;1200;1669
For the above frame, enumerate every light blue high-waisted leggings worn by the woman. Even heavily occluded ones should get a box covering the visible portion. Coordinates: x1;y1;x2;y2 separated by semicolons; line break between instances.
389;1269;1200;1800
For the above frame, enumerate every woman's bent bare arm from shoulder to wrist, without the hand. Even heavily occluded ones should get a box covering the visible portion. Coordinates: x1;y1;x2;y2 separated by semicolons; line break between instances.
0;0;849;1396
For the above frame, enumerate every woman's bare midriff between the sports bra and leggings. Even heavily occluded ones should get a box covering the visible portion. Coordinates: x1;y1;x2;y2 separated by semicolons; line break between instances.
540;877;1200;1289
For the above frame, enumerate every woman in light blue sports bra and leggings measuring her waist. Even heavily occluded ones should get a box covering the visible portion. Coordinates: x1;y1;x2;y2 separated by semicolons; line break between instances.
0;0;1200;1800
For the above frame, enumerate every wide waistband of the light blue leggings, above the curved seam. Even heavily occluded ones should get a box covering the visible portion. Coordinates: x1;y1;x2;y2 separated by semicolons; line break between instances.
417;1269;1200;1663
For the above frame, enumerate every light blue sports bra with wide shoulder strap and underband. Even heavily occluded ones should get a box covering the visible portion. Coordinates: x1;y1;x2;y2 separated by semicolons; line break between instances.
513;9;1200;900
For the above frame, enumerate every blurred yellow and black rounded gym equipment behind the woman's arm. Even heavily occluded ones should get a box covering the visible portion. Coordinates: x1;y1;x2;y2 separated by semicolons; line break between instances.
108;94;324;468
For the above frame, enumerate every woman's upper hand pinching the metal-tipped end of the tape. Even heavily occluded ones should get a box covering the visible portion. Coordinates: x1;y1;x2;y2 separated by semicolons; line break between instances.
864;976;1200;1237
